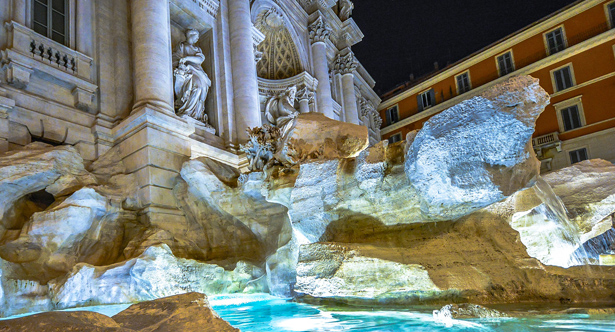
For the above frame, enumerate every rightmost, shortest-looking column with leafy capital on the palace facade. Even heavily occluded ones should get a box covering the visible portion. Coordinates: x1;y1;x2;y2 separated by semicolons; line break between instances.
335;52;359;124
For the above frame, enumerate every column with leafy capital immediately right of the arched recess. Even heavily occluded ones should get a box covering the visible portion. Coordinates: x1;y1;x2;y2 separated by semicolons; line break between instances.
309;16;335;119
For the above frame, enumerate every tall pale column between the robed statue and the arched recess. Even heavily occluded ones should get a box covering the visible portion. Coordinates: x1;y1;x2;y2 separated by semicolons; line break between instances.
228;0;262;143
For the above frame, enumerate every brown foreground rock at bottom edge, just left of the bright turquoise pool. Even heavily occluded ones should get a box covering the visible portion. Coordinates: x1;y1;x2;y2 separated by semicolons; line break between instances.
113;293;239;332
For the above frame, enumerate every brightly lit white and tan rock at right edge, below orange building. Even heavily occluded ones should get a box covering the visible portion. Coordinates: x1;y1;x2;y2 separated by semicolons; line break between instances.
508;159;615;267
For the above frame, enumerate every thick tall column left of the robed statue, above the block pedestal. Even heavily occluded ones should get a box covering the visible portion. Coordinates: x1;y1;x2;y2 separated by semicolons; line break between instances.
131;0;174;114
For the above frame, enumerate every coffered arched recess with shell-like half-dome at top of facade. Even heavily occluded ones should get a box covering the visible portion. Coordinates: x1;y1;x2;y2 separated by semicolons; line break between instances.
252;0;308;80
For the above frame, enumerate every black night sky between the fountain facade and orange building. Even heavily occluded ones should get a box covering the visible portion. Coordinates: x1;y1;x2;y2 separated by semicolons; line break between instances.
352;0;575;95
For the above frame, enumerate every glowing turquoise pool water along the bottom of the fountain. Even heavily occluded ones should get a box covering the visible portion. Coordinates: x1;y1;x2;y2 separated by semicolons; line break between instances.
1;294;615;332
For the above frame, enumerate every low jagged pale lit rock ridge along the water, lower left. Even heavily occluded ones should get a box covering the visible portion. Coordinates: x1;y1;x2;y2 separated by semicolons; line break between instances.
49;244;266;309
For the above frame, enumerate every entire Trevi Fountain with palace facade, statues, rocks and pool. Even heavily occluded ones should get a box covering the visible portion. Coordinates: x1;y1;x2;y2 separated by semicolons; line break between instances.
0;0;615;331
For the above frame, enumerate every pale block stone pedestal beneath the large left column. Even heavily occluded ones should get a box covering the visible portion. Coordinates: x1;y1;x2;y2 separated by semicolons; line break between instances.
112;107;194;224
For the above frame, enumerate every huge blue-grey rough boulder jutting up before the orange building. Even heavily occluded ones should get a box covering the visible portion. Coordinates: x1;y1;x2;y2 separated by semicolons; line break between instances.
406;76;549;220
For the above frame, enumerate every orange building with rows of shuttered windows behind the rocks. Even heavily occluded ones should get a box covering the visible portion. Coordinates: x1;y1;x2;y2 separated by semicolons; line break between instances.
378;0;615;172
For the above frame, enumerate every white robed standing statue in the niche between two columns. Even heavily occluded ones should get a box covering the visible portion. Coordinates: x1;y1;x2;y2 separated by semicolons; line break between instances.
173;29;215;132
